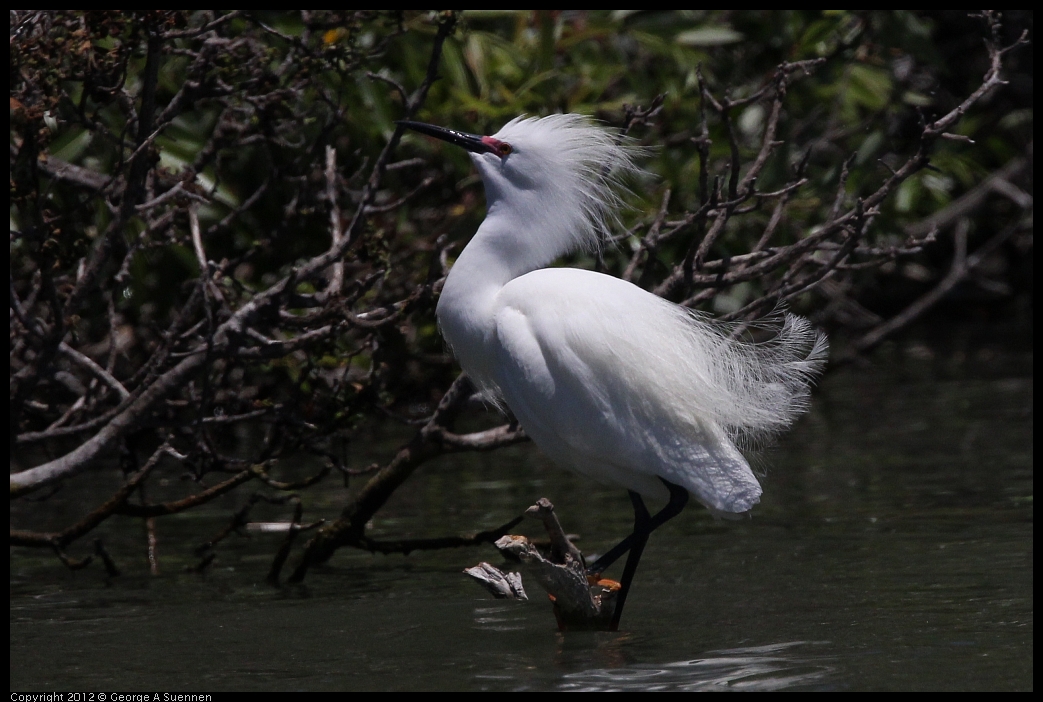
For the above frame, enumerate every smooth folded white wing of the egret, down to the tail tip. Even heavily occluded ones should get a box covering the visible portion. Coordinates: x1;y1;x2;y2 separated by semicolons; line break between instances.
491;269;760;512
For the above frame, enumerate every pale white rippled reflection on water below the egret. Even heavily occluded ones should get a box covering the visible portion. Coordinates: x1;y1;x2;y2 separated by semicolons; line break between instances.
558;642;833;692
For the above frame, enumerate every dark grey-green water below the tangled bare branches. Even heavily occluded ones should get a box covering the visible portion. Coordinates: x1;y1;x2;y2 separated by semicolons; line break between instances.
10;329;1034;693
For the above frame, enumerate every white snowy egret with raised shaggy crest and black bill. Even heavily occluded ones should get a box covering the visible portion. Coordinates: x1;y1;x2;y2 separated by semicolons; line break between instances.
402;115;827;630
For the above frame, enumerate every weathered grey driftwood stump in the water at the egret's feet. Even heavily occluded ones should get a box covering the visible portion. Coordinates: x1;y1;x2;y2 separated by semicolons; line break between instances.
464;498;620;631
